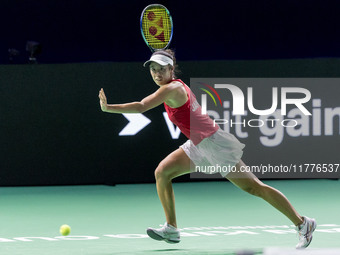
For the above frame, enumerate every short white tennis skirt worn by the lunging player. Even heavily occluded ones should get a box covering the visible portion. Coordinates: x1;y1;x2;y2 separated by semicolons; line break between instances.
180;129;245;177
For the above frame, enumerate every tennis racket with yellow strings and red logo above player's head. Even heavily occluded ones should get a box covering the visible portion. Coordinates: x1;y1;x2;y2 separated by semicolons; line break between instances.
140;4;173;52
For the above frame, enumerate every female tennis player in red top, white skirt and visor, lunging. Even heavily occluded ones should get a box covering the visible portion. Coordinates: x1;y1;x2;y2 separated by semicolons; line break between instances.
99;50;316;248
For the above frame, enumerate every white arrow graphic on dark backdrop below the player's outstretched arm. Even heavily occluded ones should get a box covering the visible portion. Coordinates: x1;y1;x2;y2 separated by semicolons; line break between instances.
119;113;151;136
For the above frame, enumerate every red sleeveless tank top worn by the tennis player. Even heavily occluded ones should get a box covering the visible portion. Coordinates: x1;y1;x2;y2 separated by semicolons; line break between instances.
164;79;219;145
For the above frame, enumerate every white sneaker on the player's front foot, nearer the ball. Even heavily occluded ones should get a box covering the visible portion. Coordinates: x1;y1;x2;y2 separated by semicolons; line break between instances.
146;222;181;243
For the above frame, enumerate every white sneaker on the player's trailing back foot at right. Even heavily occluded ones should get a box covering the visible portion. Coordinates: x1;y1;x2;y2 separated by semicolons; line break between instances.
295;216;316;249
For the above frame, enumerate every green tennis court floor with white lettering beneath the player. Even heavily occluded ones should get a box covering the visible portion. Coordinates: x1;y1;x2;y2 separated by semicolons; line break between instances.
0;180;340;255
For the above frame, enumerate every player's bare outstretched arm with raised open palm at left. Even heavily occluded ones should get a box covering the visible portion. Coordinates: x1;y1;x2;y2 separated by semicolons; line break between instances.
99;85;174;113
